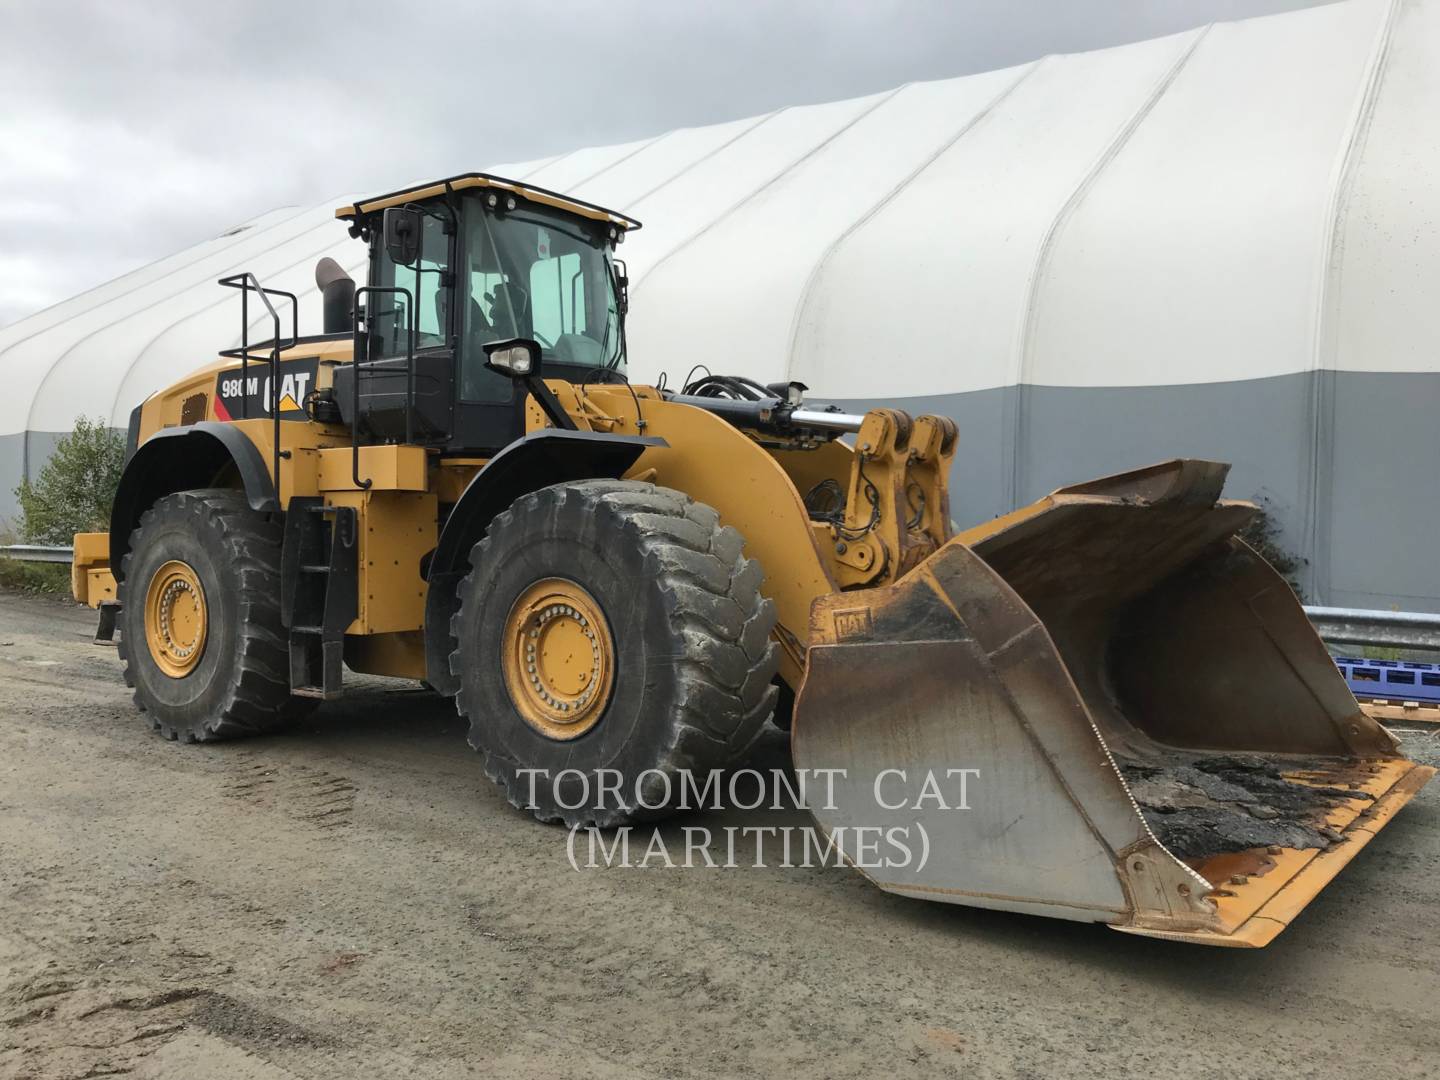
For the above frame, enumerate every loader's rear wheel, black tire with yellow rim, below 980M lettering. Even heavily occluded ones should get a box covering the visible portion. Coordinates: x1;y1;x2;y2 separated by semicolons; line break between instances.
120;488;317;743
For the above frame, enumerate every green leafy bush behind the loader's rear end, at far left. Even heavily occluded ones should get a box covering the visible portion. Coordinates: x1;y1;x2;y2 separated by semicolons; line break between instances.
14;416;125;544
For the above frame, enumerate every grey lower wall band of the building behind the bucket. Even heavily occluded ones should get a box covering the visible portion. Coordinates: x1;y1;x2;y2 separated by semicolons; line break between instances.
838;373;1440;611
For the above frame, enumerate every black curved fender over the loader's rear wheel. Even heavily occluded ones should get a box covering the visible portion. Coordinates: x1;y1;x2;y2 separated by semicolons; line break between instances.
109;420;279;582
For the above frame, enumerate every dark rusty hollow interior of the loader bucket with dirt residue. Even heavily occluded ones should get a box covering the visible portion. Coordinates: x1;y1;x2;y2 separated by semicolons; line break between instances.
975;498;1397;873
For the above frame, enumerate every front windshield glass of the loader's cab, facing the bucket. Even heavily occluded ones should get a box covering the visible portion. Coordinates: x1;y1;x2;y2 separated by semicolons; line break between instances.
458;204;624;396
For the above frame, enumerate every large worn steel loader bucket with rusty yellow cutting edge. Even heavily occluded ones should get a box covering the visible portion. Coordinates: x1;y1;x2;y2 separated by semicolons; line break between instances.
792;461;1434;948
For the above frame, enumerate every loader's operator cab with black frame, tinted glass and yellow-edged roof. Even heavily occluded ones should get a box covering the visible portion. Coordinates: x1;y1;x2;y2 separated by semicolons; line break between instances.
334;173;639;454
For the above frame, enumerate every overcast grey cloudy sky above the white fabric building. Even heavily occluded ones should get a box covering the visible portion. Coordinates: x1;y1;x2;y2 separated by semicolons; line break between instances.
0;0;1313;325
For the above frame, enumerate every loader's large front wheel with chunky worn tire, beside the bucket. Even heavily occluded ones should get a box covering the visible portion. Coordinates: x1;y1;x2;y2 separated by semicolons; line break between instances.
451;480;779;828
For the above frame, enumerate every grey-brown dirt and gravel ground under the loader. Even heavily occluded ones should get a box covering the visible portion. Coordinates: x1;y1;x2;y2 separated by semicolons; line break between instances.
0;593;1440;1080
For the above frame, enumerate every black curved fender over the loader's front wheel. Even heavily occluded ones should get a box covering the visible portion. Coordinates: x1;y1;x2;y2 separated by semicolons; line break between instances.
425;428;670;697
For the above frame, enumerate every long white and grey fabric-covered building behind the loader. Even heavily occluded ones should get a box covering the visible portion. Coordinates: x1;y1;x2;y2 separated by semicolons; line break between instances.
0;0;1440;611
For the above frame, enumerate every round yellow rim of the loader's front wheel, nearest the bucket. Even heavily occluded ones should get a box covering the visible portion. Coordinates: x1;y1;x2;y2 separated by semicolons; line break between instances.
501;577;615;739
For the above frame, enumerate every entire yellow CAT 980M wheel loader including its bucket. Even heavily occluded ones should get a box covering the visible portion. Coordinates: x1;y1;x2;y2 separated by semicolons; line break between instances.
73;173;1434;946
